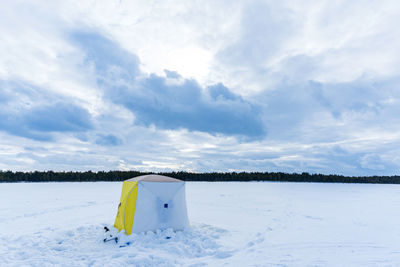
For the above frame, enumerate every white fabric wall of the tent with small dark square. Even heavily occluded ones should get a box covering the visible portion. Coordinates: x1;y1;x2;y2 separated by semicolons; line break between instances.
132;181;189;233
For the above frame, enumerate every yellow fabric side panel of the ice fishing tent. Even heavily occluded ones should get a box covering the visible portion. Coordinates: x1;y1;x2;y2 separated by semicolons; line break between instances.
114;182;138;234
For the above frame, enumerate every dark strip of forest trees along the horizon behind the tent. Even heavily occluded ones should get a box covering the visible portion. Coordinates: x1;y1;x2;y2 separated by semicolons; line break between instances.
0;171;400;184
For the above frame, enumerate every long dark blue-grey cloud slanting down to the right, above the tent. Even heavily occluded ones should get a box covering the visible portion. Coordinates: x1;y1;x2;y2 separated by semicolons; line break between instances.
73;32;265;138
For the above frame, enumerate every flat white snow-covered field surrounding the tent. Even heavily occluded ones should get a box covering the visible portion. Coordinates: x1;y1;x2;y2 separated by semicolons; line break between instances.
0;182;400;266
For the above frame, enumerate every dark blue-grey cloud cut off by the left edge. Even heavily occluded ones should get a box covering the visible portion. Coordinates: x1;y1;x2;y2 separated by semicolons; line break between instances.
0;81;93;141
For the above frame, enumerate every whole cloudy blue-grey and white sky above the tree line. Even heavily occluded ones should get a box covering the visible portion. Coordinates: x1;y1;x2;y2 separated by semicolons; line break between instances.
0;0;400;175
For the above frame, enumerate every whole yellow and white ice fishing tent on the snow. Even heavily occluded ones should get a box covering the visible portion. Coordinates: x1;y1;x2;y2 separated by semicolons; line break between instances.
114;174;189;235
